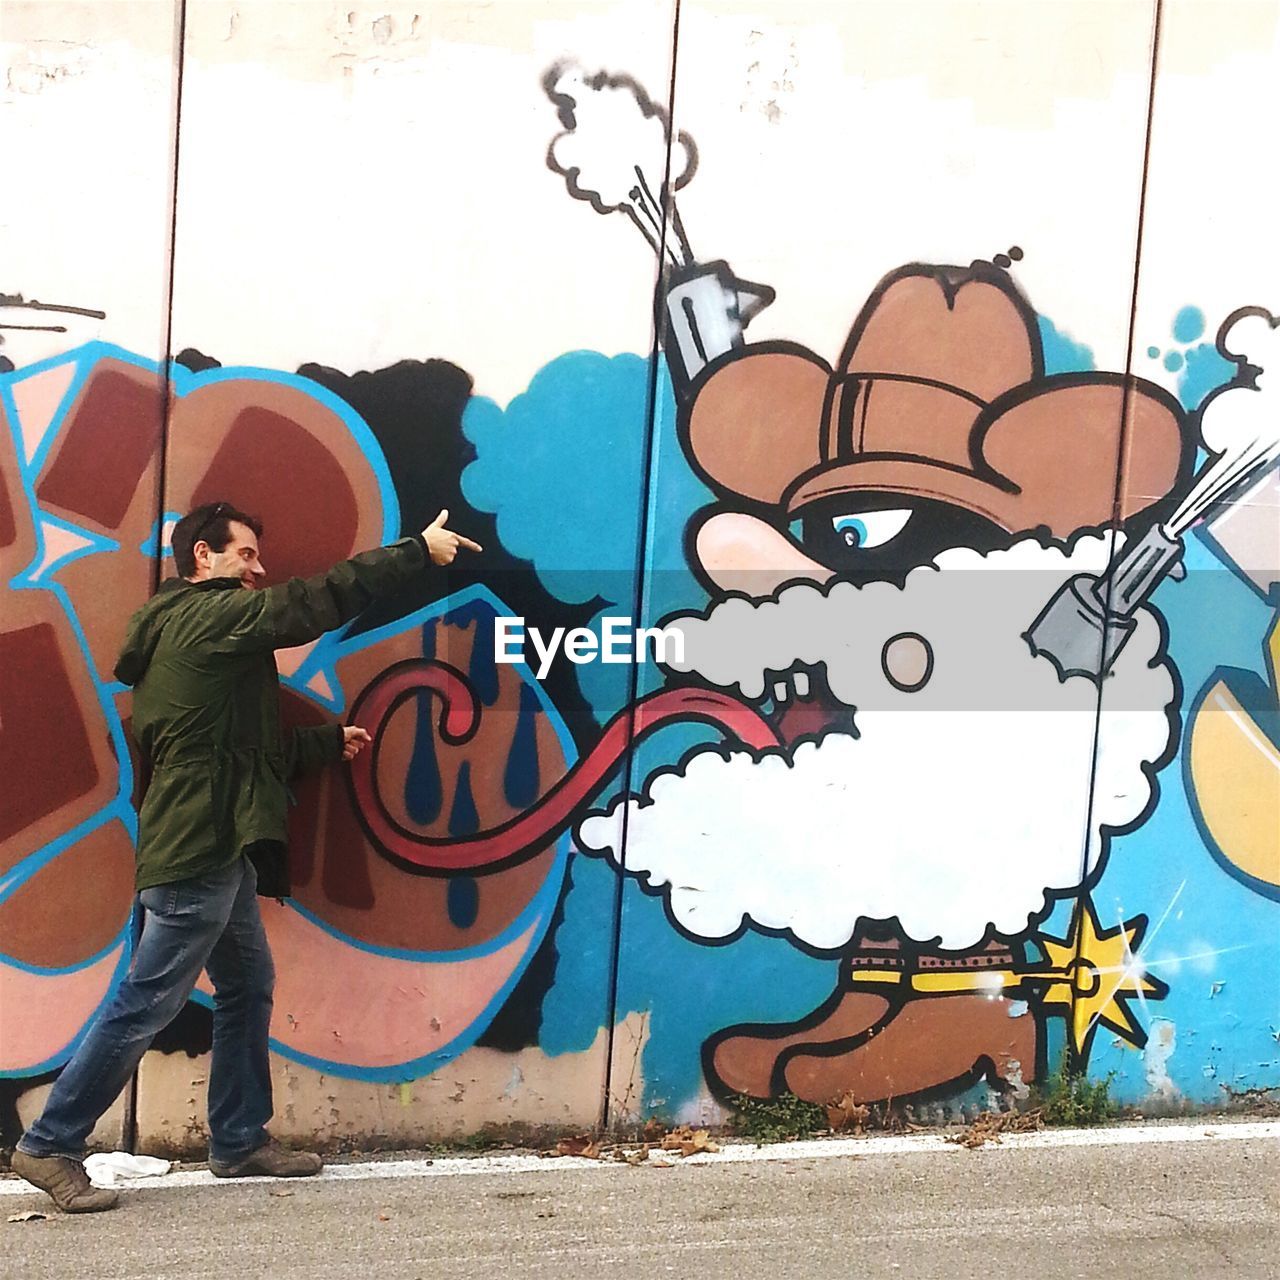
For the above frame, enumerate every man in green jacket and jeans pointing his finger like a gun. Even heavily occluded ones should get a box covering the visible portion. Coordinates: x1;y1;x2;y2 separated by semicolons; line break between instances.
13;502;480;1213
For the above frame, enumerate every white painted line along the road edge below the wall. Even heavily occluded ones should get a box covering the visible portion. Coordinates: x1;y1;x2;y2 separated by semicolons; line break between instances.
0;1120;1280;1196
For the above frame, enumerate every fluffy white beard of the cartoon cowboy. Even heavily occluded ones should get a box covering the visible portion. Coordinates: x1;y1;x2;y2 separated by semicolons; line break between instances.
577;538;1176;950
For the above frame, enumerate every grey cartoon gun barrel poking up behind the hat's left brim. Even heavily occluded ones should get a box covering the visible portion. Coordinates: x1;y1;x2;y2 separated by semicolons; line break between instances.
662;261;774;393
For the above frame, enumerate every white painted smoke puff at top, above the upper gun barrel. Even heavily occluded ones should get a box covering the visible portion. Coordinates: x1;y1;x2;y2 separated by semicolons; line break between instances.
543;63;696;244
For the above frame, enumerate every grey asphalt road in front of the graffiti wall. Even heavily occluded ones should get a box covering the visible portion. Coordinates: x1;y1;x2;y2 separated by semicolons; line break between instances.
0;1137;1280;1280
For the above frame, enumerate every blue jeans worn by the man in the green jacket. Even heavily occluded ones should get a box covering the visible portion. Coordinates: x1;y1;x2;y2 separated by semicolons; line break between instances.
18;856;275;1164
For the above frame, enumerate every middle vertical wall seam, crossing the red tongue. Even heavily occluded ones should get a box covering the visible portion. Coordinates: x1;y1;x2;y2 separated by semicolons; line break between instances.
600;0;680;1129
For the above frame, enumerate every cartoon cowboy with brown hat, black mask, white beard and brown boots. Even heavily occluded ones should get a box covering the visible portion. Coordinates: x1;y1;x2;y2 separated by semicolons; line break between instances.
579;262;1193;1102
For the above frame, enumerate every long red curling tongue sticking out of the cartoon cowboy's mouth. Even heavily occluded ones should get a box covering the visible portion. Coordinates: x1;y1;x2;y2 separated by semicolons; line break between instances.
348;659;782;874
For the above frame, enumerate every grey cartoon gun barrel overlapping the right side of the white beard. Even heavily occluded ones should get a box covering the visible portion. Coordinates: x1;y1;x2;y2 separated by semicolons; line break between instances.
1024;525;1185;682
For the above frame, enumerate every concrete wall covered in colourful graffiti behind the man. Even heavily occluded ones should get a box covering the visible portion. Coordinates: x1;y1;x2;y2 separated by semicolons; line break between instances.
0;0;1280;1149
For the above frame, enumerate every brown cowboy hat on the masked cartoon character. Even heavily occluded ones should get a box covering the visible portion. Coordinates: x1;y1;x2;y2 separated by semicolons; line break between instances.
684;262;1194;538
